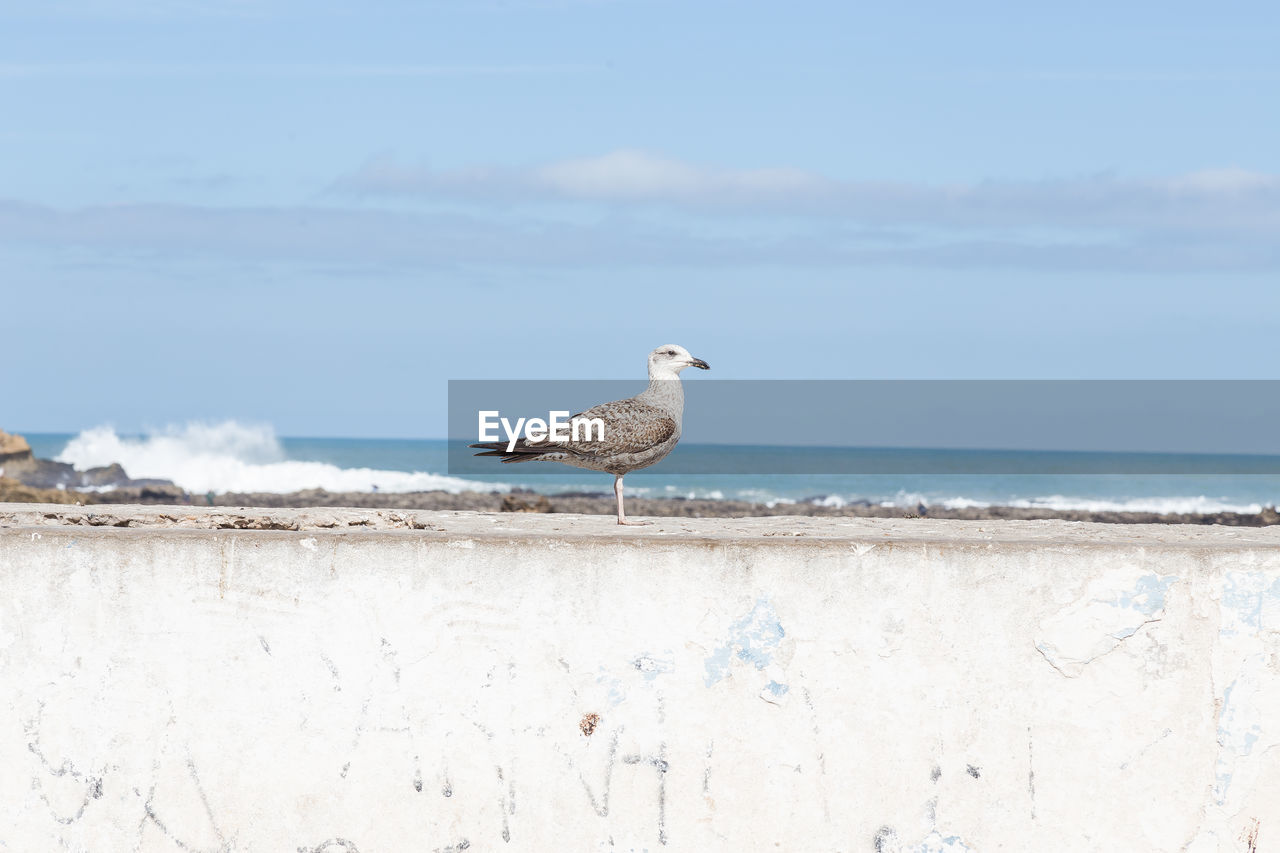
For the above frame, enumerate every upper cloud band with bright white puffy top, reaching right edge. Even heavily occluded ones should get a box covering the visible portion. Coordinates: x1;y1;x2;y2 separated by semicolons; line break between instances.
335;150;1280;234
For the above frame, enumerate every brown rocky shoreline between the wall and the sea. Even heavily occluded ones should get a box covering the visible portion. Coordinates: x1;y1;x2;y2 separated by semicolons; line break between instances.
0;432;1280;528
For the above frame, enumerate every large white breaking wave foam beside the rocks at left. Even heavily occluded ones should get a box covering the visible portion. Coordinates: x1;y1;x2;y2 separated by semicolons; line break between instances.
58;421;509;494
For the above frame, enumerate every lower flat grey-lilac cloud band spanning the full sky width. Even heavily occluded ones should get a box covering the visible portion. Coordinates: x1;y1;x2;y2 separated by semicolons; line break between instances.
0;194;1280;273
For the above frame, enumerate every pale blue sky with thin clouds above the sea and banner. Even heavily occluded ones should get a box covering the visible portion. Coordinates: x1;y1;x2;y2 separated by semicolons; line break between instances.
0;0;1280;438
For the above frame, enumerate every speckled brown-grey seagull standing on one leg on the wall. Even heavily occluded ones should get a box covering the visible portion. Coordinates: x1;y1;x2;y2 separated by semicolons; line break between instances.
471;343;710;524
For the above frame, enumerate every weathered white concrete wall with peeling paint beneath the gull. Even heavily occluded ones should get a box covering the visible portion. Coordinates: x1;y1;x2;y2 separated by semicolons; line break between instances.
0;505;1280;853
